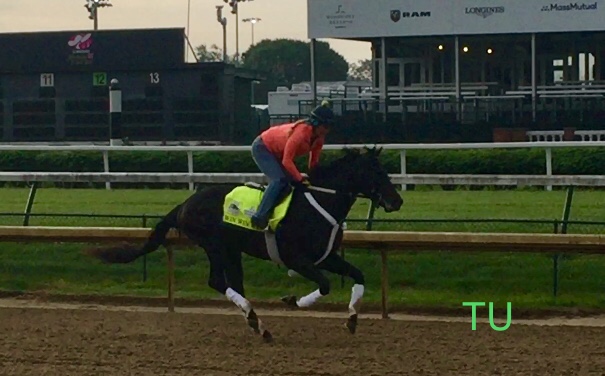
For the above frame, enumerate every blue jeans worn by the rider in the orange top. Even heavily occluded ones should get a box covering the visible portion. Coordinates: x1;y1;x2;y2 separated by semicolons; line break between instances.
252;136;292;220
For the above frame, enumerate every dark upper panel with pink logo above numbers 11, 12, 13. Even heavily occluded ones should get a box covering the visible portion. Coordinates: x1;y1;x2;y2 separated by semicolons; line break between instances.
0;28;185;73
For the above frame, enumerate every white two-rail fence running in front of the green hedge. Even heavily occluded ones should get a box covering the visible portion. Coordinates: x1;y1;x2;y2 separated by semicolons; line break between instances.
0;141;605;190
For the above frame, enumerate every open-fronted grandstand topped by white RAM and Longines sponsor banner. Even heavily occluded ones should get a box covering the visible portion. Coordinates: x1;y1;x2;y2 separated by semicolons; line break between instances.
301;0;605;141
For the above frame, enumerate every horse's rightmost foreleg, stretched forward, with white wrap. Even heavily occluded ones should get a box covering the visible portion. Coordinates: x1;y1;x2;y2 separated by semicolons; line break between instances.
318;253;365;333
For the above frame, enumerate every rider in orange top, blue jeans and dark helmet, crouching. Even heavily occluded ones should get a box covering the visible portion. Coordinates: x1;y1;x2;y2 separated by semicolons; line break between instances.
251;101;334;229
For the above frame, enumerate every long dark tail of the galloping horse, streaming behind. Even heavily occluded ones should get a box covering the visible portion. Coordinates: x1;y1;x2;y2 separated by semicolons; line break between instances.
86;204;183;264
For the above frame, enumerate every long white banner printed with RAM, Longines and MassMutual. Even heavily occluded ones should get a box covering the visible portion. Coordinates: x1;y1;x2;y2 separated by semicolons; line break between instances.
307;0;605;39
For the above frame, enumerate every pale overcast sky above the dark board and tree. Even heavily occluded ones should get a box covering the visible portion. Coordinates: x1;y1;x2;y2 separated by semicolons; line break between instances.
0;0;371;62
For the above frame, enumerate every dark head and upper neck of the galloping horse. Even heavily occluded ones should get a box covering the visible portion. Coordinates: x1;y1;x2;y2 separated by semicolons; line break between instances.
309;148;403;213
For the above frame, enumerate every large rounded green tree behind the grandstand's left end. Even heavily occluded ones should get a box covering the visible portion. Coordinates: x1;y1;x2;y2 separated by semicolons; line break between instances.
242;39;349;103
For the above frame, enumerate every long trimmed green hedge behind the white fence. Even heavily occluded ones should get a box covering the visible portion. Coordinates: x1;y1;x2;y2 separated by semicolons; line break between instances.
0;147;605;186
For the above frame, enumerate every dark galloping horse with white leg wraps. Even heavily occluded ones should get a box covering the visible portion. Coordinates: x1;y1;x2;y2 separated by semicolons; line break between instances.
90;148;403;340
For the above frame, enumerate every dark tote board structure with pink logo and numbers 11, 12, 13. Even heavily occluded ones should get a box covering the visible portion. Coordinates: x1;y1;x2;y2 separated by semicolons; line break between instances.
0;28;263;144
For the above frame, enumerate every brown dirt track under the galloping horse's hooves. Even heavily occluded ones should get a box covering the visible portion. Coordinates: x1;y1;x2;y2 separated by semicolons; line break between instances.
0;299;605;376
